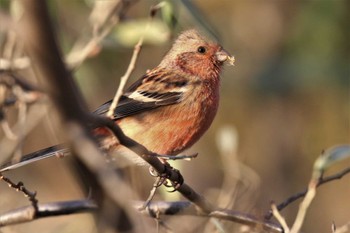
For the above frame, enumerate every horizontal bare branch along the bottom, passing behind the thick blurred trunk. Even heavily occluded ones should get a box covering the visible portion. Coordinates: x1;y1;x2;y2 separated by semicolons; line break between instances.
0;199;283;233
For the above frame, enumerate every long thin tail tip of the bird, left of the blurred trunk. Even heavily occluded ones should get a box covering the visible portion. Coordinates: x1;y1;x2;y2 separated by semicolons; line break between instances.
0;144;70;172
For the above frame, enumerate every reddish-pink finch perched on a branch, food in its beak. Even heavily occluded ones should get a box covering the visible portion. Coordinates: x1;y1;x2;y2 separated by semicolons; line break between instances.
0;30;234;171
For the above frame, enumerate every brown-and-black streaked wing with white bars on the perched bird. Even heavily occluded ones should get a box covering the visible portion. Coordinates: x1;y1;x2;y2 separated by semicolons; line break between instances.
94;70;187;120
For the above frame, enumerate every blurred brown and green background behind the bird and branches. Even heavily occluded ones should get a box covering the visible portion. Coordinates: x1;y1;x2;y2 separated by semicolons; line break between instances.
0;0;350;233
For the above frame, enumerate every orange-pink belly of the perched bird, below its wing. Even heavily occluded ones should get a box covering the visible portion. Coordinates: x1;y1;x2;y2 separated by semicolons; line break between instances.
119;100;216;155
